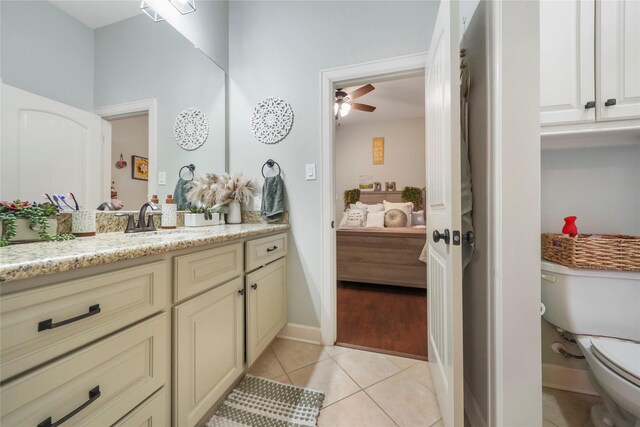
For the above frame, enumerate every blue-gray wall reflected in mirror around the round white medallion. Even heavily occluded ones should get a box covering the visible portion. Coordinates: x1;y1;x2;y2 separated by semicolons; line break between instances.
95;15;226;194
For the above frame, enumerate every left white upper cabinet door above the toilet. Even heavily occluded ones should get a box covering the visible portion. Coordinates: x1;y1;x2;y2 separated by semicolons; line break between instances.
540;0;596;126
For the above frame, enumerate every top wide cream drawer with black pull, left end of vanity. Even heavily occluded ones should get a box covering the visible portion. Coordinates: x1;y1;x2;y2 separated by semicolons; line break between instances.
0;261;169;381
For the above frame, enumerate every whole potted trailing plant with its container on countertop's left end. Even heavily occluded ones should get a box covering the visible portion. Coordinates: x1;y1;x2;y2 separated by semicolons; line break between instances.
0;200;74;246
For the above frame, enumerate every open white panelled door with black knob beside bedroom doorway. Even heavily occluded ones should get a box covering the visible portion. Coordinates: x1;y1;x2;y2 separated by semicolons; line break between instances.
426;1;464;426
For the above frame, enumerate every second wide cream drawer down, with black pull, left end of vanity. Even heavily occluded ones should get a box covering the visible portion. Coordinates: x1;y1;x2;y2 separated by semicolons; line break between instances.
0;313;169;427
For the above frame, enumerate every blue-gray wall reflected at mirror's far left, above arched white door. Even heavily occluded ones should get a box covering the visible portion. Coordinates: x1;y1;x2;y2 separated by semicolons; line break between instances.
0;0;93;111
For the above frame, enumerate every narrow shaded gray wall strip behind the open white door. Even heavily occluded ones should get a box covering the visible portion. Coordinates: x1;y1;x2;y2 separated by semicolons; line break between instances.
461;5;491;422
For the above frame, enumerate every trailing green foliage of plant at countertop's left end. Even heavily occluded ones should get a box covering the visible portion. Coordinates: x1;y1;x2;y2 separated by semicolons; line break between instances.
0;200;75;247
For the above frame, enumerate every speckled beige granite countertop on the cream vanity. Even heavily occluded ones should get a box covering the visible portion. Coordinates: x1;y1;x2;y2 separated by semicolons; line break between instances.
0;224;289;282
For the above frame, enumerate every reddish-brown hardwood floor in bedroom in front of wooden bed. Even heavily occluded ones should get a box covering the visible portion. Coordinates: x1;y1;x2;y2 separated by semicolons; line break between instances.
337;282;427;360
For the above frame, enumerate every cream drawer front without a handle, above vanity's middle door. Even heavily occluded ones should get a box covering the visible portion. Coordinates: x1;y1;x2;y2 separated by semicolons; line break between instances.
174;243;243;302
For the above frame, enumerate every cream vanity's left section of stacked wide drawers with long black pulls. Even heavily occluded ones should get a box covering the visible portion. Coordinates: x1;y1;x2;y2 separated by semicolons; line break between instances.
0;261;170;427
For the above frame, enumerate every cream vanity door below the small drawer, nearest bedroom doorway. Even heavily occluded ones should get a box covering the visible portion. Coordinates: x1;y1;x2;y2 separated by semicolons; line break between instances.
247;258;287;366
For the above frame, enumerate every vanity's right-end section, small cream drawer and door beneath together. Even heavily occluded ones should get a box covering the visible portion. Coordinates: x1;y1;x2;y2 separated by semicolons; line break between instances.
246;234;287;366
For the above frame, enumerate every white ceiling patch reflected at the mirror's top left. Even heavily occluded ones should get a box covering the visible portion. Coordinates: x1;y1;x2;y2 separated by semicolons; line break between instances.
49;0;142;30
